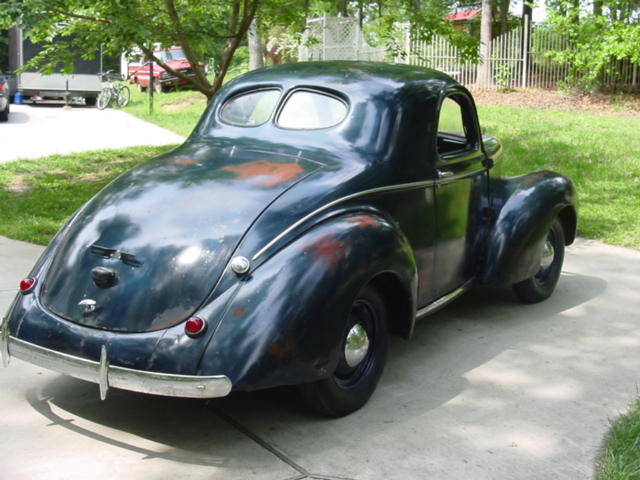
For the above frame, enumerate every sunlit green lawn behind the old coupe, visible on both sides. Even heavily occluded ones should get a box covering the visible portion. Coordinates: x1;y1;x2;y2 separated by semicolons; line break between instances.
0;91;640;248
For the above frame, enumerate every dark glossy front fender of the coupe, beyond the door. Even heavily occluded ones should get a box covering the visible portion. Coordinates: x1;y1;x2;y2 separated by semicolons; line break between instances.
480;171;576;285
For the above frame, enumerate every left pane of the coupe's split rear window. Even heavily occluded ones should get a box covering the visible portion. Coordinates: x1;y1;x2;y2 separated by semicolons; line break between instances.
220;88;280;127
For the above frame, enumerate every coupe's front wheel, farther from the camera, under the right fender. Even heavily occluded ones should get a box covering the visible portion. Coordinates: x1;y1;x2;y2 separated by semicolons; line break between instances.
513;219;564;303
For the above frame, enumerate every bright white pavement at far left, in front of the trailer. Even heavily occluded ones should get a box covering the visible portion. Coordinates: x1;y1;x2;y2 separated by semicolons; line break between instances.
0;104;184;163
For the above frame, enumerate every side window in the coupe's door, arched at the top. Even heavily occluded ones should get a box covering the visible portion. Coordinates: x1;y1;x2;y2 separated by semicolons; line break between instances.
437;96;475;154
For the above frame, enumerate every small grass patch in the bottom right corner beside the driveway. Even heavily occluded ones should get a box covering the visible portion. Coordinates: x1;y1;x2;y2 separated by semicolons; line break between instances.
596;399;640;480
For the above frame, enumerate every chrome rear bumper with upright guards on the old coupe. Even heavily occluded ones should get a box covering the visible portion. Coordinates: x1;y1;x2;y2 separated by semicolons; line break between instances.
0;321;231;400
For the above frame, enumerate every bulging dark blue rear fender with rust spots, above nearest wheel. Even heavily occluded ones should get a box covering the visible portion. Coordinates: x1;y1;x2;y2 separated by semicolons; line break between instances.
199;212;417;390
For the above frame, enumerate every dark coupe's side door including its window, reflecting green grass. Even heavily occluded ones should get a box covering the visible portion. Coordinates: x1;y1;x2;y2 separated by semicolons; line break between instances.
434;90;487;297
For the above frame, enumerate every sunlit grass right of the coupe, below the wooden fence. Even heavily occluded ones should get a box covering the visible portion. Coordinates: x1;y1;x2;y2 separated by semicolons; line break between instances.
479;106;640;248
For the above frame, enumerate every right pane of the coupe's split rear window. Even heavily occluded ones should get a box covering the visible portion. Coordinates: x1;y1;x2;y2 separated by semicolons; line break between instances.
277;90;347;130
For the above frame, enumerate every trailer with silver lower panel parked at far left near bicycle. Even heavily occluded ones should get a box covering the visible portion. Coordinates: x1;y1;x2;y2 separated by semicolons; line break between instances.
9;26;102;105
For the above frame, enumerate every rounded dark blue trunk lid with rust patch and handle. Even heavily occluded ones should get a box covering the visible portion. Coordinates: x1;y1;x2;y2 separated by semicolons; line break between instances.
40;144;321;332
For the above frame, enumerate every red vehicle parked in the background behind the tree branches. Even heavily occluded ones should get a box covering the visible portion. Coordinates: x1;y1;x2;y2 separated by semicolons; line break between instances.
127;47;200;92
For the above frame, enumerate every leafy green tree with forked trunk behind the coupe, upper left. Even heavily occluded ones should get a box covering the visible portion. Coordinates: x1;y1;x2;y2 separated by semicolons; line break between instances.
0;0;304;99
